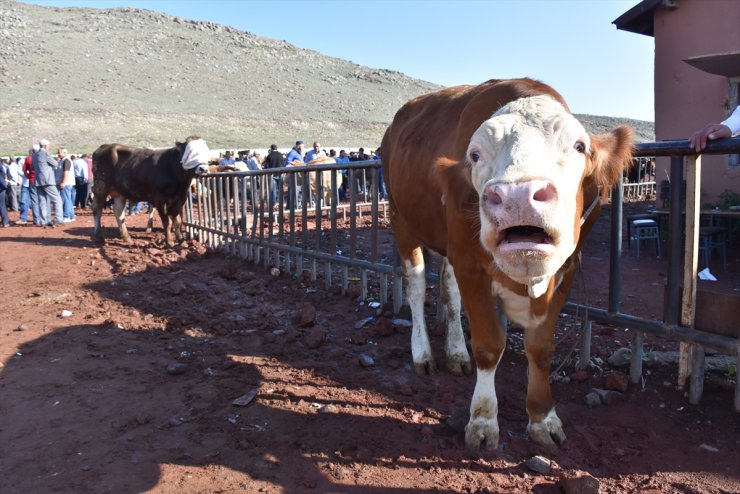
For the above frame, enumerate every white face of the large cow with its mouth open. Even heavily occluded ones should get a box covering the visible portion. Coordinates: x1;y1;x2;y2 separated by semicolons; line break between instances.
467;95;591;296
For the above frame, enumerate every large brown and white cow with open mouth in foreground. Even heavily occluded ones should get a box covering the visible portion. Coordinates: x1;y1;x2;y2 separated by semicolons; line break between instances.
382;79;632;449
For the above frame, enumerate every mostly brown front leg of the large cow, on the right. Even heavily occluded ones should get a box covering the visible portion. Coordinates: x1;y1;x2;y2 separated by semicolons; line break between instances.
524;322;565;447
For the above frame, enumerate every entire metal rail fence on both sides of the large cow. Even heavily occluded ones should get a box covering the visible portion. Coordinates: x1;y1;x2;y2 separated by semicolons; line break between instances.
185;144;740;411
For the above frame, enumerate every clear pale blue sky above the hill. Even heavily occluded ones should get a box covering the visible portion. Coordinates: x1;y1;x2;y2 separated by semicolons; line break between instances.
25;0;655;121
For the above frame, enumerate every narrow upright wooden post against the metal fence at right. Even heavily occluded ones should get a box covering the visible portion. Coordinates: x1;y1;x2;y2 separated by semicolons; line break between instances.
672;156;704;394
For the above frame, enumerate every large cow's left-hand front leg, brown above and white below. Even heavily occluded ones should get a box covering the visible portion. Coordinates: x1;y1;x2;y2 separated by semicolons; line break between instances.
456;269;506;451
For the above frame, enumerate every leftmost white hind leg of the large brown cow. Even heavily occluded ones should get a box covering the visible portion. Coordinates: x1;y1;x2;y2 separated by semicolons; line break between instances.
397;245;437;375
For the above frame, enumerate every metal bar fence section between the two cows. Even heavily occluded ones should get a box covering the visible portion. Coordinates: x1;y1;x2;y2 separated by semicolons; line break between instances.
185;161;402;310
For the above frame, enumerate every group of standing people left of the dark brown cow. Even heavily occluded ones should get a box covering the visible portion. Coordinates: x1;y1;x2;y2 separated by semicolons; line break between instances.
0;139;92;228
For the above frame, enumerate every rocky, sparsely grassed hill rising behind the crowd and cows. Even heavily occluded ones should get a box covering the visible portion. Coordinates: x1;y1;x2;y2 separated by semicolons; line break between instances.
0;0;654;154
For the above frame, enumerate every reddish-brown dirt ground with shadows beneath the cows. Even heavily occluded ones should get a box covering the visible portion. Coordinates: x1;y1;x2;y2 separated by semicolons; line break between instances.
0;203;740;493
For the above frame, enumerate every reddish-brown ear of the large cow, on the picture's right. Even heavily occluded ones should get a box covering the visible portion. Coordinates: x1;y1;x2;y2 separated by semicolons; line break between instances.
590;125;633;188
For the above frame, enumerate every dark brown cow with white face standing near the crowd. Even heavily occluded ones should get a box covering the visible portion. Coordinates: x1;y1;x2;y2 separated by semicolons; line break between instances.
92;136;210;247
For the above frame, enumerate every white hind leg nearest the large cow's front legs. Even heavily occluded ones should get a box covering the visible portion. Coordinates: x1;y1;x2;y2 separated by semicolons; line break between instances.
439;257;473;374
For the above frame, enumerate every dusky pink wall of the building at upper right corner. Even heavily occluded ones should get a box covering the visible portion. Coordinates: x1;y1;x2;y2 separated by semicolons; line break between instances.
654;0;740;203
